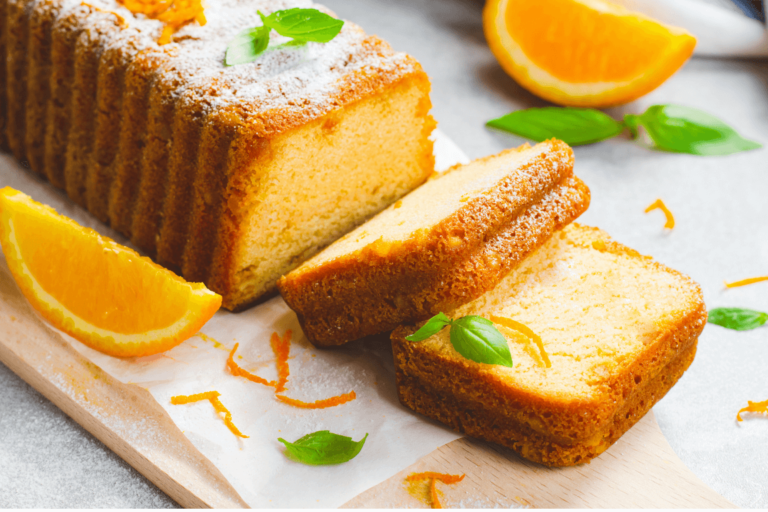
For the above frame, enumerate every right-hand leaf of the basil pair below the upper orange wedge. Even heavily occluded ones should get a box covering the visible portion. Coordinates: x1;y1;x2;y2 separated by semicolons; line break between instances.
624;105;763;156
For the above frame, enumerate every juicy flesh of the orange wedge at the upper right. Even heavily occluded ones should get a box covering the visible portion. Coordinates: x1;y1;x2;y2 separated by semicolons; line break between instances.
505;0;688;84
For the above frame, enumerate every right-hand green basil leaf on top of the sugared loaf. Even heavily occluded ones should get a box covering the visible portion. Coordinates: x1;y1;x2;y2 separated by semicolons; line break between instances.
259;7;344;43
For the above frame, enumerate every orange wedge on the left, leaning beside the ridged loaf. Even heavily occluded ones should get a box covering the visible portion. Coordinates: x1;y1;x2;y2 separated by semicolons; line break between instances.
0;187;221;357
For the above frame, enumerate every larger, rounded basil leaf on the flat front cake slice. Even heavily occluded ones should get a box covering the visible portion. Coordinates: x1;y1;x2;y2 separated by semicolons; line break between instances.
451;315;512;368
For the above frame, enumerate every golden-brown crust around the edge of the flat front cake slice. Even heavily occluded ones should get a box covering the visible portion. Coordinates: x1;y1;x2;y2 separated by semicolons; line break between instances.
391;225;707;465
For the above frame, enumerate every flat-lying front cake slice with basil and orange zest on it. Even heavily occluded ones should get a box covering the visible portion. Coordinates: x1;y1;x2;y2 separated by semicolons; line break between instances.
391;224;707;466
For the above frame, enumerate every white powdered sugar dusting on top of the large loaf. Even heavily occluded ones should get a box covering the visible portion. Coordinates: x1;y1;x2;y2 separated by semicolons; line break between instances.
67;0;414;119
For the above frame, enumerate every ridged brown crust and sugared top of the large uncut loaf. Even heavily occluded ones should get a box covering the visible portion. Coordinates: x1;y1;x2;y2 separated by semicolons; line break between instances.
0;0;434;308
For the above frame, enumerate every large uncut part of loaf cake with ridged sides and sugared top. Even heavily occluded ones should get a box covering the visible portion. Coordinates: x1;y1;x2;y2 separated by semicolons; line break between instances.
0;0;435;309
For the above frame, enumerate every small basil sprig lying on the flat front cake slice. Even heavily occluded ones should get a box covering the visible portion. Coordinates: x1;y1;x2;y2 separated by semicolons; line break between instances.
405;313;512;368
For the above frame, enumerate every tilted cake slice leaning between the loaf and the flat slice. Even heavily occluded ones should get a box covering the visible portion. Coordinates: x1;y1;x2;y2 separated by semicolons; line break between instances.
278;139;589;346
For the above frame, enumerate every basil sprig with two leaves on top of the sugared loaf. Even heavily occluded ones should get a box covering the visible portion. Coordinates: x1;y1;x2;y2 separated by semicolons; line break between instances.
224;7;344;66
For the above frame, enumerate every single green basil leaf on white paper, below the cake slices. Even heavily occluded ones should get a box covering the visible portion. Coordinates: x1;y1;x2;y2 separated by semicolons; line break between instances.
278;430;368;466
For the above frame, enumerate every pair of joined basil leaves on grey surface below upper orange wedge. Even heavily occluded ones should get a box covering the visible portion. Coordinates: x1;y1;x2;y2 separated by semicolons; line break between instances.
486;105;763;156
